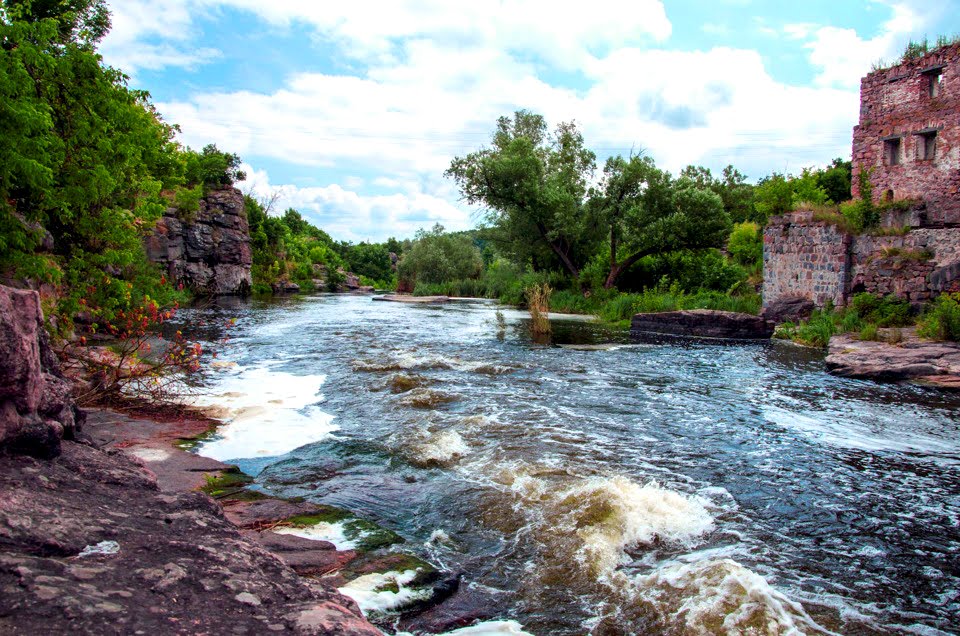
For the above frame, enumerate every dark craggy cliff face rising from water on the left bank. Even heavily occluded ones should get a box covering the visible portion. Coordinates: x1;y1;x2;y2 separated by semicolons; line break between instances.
145;188;253;296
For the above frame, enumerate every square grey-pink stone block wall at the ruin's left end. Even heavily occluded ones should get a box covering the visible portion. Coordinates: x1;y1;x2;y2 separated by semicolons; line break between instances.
763;211;851;307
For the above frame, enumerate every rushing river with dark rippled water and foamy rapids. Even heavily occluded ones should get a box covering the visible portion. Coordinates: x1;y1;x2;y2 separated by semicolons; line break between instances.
172;295;960;635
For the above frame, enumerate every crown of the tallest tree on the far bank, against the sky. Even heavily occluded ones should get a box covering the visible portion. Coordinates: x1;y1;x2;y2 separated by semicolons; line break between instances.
445;110;595;279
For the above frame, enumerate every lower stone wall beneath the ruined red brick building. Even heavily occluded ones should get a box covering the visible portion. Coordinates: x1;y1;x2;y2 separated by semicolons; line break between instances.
763;211;960;307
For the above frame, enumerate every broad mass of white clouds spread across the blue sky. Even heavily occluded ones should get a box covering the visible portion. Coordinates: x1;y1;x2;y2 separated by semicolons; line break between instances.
105;0;944;240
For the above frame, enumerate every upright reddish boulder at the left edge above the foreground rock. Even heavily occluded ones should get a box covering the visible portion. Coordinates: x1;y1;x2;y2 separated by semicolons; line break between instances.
0;285;83;458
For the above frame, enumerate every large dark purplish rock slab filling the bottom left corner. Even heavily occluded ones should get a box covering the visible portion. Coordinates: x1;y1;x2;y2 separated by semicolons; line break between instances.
0;442;379;634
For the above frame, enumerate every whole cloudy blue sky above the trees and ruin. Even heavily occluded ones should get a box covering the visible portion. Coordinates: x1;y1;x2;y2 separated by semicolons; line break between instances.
101;0;960;242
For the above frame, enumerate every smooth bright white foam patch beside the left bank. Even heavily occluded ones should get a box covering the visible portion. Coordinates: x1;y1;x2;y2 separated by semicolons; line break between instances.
194;364;339;461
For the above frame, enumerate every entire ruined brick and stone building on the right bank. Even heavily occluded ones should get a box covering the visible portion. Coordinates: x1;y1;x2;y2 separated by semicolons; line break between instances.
763;44;960;307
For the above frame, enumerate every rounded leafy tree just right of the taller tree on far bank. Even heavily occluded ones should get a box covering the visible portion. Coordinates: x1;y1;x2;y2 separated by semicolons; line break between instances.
589;155;730;289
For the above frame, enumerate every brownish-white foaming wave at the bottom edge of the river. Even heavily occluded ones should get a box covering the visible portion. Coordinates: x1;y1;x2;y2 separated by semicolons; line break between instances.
633;559;829;636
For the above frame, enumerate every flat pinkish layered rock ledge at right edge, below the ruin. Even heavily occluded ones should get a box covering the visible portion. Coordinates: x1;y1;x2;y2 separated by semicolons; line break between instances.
826;329;960;389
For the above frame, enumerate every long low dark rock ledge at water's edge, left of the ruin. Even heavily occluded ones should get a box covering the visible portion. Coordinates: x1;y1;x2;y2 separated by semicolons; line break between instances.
630;309;773;340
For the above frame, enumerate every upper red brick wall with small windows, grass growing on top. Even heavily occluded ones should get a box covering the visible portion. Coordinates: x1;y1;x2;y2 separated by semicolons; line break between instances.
853;44;960;227
